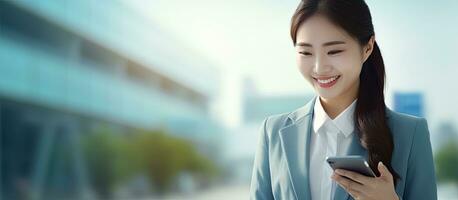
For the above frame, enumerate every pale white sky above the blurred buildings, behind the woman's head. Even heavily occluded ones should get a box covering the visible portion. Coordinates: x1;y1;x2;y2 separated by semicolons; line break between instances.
130;0;458;130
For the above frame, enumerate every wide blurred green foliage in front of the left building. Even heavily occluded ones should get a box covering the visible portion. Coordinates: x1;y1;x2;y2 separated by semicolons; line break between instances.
82;126;219;199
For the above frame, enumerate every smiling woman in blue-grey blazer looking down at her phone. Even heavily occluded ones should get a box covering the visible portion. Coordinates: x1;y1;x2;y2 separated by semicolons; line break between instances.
251;0;437;199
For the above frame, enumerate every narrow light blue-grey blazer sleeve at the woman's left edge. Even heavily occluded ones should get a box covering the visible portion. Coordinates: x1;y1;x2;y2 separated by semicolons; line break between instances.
250;118;273;200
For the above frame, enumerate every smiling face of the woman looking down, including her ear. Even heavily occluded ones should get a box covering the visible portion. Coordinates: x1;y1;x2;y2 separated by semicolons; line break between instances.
296;15;373;100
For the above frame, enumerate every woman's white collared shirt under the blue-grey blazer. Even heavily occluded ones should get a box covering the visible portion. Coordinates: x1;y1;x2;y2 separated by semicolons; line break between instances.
309;97;356;200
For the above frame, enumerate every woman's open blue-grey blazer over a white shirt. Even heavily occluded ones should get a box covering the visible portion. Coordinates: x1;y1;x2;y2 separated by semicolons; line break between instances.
250;97;437;200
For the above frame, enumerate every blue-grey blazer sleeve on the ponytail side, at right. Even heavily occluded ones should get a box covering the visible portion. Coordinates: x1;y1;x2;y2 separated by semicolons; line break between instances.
403;119;437;200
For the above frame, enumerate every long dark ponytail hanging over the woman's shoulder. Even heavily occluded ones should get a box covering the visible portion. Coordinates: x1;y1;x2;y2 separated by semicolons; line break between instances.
354;42;399;184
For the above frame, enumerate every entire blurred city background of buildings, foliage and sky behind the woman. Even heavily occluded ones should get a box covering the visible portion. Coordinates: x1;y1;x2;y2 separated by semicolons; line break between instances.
0;0;458;200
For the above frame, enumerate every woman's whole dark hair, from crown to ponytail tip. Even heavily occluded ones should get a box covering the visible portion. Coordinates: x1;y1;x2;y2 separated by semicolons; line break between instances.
291;0;399;185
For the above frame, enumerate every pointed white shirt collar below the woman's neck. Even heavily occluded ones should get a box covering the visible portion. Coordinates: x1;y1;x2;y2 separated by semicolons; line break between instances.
313;97;356;137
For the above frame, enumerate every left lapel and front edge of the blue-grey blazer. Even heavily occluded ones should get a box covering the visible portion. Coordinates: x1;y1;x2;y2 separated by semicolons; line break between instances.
280;99;315;200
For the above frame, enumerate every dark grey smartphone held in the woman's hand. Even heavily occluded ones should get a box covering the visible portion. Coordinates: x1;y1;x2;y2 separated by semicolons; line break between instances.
326;156;376;177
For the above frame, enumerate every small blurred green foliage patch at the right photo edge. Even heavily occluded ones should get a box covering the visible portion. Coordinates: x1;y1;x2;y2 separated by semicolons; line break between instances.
435;141;458;183
